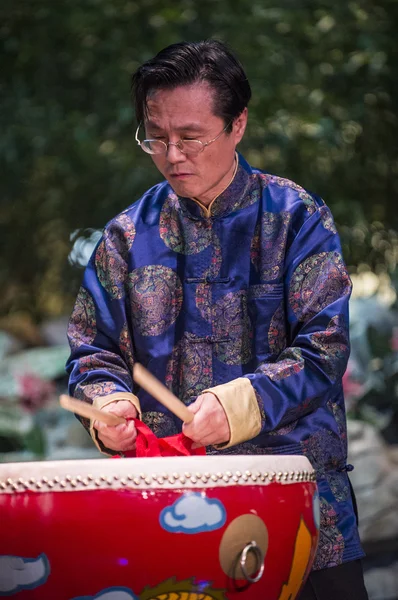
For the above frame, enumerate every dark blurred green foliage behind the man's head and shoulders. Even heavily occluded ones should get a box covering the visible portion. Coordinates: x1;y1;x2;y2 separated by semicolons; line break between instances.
0;0;398;320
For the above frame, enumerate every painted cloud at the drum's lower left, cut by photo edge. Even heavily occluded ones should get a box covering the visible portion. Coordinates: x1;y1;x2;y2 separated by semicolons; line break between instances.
0;554;50;597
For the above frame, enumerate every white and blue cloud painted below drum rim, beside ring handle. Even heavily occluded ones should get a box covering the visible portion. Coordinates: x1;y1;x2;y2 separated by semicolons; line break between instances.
159;492;227;533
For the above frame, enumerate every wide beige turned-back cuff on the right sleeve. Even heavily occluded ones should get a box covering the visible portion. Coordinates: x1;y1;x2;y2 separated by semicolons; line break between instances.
202;377;261;450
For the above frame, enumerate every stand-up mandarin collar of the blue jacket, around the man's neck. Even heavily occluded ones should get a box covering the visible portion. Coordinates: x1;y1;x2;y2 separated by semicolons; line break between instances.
178;152;252;220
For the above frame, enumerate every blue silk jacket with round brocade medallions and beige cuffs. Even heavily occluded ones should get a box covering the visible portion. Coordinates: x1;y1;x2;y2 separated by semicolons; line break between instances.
67;156;363;569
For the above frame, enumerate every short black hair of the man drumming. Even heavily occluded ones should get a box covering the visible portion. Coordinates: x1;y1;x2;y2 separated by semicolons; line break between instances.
132;39;251;132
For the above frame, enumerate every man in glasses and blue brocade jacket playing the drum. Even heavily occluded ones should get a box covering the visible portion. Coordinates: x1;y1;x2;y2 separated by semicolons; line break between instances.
68;40;367;600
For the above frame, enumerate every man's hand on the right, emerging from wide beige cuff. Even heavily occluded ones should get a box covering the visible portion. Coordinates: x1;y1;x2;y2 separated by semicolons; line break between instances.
182;392;231;446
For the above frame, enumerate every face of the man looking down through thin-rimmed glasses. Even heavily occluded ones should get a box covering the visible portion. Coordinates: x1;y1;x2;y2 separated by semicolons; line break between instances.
144;82;247;205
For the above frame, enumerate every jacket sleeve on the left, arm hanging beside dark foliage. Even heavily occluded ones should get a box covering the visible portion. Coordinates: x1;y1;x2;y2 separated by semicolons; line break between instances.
66;213;140;453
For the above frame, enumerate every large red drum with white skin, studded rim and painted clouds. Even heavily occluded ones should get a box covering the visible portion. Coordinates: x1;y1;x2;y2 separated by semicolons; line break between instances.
0;455;319;600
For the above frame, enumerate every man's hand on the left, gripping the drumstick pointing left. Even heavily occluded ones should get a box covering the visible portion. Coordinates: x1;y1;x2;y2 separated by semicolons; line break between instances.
93;400;138;452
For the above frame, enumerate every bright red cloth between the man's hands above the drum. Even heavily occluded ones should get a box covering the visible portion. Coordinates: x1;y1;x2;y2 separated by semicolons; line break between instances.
115;419;206;458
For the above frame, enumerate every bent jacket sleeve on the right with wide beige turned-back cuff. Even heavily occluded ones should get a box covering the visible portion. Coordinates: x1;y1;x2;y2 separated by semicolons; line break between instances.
207;204;351;448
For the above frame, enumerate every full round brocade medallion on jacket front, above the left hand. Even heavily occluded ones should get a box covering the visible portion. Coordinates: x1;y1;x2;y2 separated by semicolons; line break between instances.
128;265;182;336
